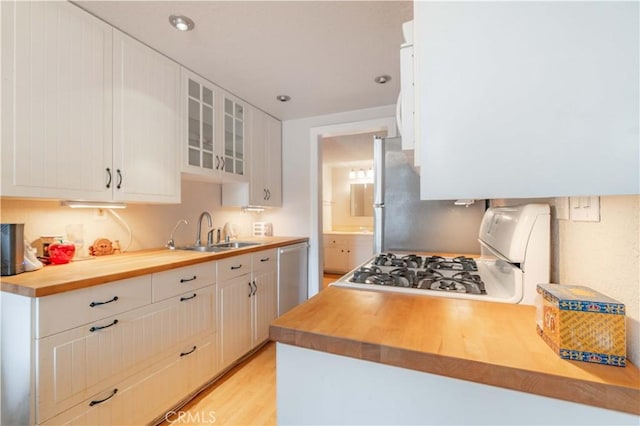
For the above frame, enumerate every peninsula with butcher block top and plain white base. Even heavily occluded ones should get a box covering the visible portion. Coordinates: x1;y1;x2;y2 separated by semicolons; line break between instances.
270;287;640;425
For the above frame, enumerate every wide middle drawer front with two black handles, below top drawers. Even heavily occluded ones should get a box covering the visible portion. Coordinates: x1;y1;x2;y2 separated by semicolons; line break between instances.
37;286;216;420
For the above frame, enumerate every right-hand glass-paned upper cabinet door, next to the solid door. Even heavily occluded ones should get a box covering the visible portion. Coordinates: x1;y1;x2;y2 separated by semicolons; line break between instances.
218;93;248;182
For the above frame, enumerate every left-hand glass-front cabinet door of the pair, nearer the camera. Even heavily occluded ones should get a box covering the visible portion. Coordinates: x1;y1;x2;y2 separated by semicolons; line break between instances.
182;68;222;177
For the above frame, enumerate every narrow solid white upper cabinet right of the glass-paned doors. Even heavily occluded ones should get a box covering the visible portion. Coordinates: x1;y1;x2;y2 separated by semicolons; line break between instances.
249;108;282;207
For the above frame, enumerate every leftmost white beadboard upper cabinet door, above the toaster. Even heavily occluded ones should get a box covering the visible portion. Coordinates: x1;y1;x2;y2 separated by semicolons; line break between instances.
0;1;112;200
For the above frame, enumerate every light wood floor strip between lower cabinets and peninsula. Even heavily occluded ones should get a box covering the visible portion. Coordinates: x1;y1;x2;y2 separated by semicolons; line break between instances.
161;342;276;426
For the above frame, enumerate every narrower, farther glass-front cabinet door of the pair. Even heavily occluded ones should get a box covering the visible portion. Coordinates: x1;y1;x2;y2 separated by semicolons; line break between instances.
223;95;246;176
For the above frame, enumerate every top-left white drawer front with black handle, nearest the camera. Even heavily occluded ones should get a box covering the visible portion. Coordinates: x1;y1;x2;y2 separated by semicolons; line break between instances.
35;275;151;338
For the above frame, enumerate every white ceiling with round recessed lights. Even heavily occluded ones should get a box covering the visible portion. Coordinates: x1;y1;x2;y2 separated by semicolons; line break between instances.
74;1;413;120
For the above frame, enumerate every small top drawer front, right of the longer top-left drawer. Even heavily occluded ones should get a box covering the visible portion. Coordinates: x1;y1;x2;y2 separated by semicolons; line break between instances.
151;262;216;302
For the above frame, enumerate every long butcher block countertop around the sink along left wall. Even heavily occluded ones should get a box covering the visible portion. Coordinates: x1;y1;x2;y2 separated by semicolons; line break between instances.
1;237;308;297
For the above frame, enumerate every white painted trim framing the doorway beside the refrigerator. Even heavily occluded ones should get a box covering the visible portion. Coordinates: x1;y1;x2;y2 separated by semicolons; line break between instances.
309;117;398;297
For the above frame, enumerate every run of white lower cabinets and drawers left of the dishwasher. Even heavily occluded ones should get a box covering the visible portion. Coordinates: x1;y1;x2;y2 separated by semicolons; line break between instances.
0;249;292;425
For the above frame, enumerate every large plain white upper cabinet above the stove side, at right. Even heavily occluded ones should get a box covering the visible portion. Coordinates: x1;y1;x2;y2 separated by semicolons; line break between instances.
414;2;640;200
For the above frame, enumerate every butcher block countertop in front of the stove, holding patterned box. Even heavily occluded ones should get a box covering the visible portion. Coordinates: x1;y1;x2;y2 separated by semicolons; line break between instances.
270;286;640;415
